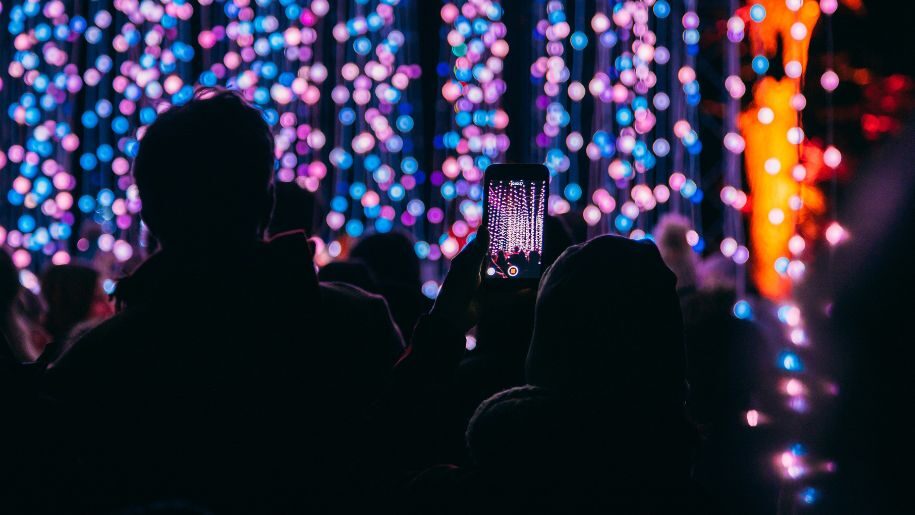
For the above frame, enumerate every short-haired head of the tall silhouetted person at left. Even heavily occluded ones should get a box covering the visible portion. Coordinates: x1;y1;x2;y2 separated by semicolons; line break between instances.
133;90;274;254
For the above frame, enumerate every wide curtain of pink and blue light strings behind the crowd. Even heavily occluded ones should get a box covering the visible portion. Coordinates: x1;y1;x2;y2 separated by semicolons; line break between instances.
0;0;702;282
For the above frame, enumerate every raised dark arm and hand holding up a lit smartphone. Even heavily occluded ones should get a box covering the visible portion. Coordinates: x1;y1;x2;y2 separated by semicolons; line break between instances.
389;164;549;467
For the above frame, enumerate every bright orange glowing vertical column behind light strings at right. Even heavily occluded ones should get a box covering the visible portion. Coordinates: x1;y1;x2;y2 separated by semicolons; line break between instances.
738;0;825;299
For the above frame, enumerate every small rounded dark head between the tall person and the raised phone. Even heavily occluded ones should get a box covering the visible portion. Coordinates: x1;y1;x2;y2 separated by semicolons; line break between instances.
350;231;420;284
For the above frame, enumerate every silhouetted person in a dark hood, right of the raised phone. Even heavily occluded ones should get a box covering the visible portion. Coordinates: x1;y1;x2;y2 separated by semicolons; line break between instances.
467;236;707;513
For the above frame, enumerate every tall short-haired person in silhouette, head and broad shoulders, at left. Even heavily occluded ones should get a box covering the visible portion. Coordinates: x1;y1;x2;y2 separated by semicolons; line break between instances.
44;90;402;513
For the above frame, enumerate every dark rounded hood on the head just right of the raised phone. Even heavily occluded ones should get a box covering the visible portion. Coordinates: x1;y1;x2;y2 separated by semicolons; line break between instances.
526;236;686;410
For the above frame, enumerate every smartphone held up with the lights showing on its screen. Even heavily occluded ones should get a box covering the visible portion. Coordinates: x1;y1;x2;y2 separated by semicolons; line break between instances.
483;164;550;285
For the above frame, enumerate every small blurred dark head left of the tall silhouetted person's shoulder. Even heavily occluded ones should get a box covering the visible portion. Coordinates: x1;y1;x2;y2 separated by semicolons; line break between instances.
41;265;111;339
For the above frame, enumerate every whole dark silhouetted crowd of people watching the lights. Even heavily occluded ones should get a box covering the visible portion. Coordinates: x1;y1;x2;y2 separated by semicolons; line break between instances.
0;91;777;514
